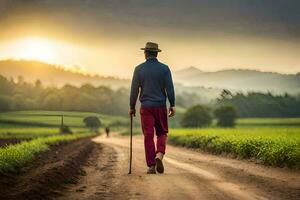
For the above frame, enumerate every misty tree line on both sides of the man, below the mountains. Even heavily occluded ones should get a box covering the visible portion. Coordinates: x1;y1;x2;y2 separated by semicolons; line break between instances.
0;75;300;117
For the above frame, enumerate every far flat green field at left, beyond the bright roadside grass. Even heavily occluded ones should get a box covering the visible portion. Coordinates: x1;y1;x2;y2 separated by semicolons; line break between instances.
0;111;128;138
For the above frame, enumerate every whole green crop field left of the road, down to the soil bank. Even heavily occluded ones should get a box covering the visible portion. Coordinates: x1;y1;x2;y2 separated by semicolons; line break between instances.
0;111;123;172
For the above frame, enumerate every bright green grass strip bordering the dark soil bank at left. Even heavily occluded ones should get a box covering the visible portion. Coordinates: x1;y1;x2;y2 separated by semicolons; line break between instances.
0;134;93;172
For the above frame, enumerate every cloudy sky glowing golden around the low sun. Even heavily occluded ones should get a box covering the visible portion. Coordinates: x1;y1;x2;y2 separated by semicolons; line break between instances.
0;0;300;78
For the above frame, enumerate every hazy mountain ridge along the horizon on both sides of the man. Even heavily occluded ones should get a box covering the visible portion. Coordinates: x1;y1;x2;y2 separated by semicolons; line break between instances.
0;60;300;97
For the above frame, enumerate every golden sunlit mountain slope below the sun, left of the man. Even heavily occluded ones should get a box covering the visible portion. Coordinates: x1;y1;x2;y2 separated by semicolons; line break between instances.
0;60;130;89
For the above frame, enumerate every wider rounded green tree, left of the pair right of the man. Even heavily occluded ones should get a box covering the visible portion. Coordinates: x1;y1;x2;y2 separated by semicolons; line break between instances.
181;105;212;127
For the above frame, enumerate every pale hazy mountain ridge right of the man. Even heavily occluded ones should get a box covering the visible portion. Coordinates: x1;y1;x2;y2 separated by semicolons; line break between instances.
173;67;300;94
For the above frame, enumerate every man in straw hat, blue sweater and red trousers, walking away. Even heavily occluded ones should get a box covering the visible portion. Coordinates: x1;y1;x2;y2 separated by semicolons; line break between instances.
129;42;175;174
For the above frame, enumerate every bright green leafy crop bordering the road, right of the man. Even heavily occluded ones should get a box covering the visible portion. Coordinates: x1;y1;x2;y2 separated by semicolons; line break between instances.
168;127;300;169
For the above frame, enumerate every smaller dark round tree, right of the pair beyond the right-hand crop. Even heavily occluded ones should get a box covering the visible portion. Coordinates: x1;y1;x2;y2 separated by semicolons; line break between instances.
214;106;237;127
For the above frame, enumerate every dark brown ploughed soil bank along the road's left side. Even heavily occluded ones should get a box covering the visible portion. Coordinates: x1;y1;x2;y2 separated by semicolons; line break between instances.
0;138;98;200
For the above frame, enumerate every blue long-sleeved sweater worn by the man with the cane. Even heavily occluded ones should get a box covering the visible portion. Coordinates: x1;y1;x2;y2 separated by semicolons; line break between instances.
130;58;175;109
